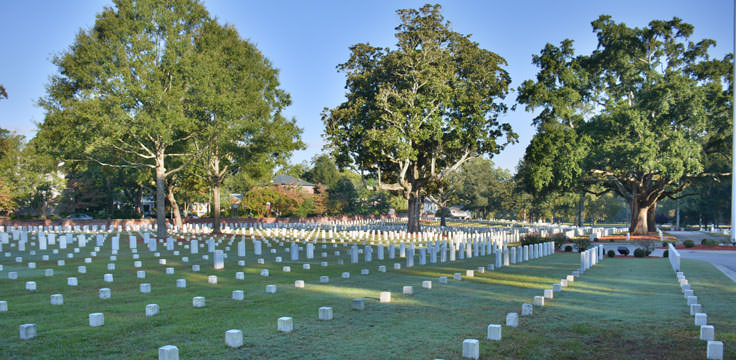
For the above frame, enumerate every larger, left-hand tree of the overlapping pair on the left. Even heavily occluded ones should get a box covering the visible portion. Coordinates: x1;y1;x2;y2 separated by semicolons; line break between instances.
37;0;221;238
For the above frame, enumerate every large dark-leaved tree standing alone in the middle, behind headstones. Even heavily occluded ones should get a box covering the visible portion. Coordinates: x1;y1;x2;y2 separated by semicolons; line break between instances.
323;5;516;232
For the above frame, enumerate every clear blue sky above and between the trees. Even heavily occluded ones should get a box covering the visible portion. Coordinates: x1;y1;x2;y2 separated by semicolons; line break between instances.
0;0;734;172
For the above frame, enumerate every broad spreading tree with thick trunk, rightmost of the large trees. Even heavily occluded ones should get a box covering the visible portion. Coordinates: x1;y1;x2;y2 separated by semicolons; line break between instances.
518;15;733;234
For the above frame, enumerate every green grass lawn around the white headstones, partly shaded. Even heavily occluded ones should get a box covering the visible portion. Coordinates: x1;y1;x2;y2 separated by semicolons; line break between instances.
0;235;736;359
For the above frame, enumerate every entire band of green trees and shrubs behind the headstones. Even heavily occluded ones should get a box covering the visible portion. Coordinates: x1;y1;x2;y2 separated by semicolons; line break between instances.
0;0;733;237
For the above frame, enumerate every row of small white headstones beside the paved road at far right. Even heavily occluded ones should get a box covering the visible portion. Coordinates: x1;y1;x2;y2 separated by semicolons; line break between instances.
667;244;723;360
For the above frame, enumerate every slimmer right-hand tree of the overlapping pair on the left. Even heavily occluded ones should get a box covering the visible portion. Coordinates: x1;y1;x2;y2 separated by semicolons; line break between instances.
193;23;303;233
